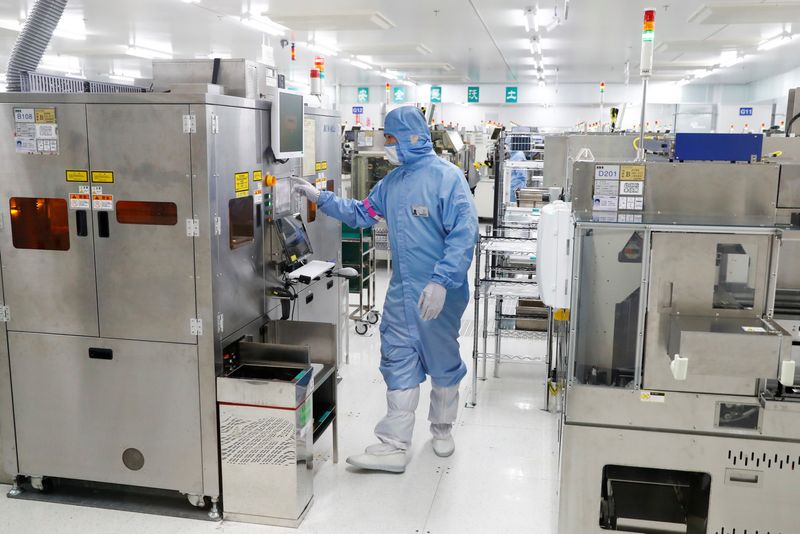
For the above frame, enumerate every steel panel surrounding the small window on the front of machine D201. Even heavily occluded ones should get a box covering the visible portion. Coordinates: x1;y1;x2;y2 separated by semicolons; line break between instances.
644;232;778;395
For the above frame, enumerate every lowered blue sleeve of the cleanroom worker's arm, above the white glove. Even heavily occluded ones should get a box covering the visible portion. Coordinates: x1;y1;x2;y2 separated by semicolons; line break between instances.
431;177;478;289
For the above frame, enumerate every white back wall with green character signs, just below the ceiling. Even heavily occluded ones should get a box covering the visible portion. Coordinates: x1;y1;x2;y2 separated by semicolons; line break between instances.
332;79;788;132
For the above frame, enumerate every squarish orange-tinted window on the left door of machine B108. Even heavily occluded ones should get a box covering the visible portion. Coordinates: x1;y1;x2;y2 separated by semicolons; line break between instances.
9;197;69;250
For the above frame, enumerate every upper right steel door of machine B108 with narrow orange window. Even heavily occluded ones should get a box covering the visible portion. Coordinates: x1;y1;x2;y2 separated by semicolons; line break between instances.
86;104;196;343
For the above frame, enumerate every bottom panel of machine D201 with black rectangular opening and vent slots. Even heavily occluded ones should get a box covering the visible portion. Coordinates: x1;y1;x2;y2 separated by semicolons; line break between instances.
558;425;800;534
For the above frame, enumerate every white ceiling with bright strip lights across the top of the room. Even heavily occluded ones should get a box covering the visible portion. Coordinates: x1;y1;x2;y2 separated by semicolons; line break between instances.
0;0;800;90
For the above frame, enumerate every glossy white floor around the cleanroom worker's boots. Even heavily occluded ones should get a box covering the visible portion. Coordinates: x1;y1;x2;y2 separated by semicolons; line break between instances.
0;270;558;534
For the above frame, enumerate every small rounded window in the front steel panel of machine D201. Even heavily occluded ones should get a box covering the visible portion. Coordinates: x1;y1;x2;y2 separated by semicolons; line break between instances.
714;243;756;310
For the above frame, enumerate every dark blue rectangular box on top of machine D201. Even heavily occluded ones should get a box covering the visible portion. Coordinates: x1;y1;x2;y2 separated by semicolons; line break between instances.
674;133;764;161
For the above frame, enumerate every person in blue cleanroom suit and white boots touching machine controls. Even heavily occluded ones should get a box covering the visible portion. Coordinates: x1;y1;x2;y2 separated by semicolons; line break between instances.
293;106;478;473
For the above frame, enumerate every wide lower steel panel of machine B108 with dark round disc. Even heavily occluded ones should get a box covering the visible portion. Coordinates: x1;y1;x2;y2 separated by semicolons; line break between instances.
9;332;203;494
